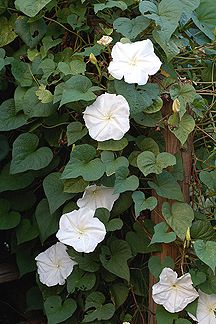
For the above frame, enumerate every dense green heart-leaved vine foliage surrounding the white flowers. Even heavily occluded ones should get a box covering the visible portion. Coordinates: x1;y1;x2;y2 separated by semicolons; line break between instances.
0;0;216;324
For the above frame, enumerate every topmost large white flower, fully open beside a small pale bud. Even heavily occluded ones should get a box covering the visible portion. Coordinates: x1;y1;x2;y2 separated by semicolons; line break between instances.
108;39;162;85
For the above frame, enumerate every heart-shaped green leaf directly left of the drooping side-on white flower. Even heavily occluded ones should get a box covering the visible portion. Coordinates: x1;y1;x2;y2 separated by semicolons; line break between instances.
43;172;73;214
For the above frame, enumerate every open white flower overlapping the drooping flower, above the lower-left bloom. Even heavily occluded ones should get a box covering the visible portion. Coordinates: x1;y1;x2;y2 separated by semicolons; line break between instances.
56;208;106;253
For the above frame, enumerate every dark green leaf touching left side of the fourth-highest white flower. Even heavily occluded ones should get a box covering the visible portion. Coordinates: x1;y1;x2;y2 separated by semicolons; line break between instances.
35;199;60;243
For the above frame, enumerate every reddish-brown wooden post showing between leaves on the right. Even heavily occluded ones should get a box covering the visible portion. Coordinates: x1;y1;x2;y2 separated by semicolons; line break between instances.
148;100;193;324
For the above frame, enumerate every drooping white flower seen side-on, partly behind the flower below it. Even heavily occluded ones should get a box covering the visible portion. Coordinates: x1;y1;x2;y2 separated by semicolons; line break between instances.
77;185;119;211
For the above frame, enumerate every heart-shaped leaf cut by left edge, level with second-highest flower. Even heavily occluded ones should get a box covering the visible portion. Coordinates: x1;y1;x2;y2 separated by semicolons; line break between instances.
0;99;27;131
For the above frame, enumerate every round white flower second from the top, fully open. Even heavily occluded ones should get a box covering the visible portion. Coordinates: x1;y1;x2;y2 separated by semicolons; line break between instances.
83;93;130;141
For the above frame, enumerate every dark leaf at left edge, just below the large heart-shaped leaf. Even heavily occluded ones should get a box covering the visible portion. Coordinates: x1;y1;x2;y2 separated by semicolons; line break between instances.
0;164;34;192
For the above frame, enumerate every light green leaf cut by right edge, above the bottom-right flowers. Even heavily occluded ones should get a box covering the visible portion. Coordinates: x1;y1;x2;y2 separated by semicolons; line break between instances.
194;240;216;273
